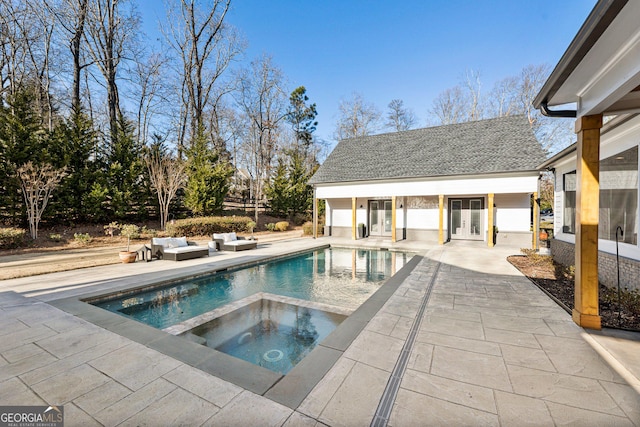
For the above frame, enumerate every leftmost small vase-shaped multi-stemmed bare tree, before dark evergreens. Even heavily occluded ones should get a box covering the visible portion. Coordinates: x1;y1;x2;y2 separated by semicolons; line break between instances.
18;162;66;240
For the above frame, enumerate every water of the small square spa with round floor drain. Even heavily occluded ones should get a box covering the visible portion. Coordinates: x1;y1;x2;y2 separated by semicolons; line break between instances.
188;298;347;374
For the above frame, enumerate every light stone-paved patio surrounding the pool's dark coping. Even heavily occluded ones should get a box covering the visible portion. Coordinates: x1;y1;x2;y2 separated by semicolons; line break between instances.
0;238;640;426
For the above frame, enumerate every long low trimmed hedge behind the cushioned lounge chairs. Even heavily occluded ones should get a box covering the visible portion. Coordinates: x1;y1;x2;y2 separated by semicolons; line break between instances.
166;216;253;237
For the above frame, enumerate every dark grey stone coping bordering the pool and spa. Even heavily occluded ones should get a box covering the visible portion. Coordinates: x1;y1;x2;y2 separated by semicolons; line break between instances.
49;244;423;409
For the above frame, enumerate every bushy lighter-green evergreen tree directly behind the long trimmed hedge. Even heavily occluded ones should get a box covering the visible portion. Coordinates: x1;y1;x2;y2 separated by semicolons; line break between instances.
184;129;233;215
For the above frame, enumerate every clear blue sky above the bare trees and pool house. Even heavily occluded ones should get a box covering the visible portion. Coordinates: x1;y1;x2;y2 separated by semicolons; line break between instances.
139;0;596;146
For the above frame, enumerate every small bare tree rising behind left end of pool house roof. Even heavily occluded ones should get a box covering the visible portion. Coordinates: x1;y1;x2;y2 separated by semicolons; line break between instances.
334;92;381;140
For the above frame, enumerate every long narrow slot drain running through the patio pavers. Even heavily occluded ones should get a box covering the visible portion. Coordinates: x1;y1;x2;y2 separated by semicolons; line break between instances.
370;261;441;427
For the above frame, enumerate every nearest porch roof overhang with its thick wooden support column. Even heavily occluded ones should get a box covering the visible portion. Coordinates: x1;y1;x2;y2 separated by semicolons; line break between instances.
534;0;640;329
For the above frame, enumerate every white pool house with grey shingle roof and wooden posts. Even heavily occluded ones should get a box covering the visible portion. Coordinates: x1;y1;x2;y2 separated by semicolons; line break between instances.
310;116;545;247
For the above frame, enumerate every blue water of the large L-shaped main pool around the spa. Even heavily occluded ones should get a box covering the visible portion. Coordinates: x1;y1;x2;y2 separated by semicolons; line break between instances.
93;248;413;329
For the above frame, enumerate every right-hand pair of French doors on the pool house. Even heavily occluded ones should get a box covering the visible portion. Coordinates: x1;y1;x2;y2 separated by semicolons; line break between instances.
449;199;484;240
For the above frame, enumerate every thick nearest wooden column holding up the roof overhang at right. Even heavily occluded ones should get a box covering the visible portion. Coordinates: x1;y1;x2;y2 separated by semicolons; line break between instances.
572;114;602;329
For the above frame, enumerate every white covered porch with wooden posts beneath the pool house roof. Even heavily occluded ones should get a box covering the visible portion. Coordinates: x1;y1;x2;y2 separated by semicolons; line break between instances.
314;191;538;251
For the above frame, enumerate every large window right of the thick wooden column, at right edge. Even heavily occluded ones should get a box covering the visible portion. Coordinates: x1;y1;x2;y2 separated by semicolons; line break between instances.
598;146;638;245
